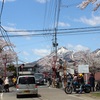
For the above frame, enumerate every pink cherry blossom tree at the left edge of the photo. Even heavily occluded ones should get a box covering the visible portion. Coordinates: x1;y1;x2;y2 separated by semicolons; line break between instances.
0;39;17;76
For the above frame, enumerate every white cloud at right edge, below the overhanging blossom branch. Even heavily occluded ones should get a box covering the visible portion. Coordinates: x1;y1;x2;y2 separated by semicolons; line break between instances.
79;16;100;26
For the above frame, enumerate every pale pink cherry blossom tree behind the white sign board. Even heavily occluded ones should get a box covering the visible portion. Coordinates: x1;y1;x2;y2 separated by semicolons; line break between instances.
73;50;100;73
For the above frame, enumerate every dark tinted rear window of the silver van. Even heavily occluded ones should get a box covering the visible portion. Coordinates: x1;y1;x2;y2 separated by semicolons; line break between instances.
19;77;35;84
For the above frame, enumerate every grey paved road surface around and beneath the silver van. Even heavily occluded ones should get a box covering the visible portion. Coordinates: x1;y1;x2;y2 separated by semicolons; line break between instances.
0;86;99;100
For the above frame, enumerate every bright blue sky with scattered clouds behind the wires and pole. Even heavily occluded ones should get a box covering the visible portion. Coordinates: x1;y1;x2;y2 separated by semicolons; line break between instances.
0;0;100;62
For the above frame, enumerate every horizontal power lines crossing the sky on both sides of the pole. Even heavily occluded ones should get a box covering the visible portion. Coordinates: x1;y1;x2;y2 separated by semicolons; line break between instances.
0;26;100;37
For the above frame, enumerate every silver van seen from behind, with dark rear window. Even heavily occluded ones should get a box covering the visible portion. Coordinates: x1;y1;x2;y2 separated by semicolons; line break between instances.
16;75;38;98
